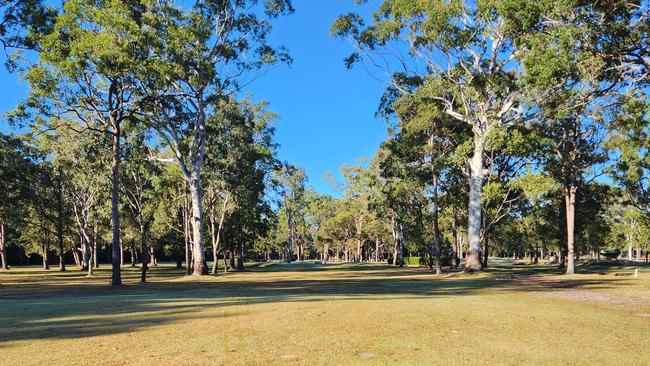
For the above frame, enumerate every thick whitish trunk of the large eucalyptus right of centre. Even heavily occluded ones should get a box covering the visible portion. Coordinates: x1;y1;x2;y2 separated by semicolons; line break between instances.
465;134;485;272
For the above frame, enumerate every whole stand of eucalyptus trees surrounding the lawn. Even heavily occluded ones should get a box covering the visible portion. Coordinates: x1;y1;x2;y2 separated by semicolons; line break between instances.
0;0;650;286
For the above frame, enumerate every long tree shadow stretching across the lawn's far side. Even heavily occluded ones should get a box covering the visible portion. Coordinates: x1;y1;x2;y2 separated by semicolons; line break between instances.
0;264;620;341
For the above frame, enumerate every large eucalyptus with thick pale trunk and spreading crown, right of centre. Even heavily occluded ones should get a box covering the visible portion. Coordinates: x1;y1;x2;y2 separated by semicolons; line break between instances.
332;0;527;271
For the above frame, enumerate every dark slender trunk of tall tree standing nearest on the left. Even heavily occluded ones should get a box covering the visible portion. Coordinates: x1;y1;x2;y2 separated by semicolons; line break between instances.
111;129;122;286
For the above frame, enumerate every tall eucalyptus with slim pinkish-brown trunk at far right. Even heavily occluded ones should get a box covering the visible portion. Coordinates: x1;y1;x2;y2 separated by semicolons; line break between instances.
507;0;650;274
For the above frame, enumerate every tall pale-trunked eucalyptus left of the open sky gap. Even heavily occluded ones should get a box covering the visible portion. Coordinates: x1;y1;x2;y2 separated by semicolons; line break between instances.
146;0;293;275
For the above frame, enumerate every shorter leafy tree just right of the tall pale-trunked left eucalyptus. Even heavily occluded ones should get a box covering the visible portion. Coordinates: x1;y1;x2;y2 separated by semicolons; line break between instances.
202;99;277;274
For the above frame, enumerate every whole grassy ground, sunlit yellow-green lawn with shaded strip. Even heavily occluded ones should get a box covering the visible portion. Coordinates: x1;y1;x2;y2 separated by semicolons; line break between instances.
0;261;650;366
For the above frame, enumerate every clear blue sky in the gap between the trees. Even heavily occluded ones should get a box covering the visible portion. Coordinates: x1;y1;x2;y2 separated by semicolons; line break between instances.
0;0;386;194
